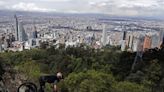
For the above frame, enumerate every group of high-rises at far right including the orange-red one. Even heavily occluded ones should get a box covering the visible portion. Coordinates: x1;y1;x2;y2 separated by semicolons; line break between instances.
121;29;164;52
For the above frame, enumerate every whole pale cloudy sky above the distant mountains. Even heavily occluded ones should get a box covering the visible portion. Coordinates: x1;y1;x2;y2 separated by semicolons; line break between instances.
0;0;164;17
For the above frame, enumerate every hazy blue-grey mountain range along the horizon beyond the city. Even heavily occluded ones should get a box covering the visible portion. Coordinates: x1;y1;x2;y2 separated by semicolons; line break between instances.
0;10;164;21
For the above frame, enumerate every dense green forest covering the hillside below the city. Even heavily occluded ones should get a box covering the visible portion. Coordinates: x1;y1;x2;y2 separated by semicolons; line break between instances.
0;45;164;92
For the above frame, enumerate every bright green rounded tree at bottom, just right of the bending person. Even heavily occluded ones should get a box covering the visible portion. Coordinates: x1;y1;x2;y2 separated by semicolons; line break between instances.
65;70;115;92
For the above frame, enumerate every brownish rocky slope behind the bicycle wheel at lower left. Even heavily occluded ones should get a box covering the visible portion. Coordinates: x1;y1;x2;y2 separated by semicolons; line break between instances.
0;66;27;92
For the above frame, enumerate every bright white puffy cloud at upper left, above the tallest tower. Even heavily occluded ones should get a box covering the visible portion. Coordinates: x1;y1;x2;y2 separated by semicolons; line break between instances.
10;2;56;12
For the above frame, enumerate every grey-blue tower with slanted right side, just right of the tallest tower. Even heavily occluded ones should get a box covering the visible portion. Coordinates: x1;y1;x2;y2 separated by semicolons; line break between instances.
18;22;28;41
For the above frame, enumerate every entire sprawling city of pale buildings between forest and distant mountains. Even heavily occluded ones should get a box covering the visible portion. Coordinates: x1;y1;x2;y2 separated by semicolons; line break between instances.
0;15;164;52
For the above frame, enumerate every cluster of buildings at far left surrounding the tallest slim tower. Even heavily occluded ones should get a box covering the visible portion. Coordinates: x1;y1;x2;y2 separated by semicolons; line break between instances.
0;15;39;52
